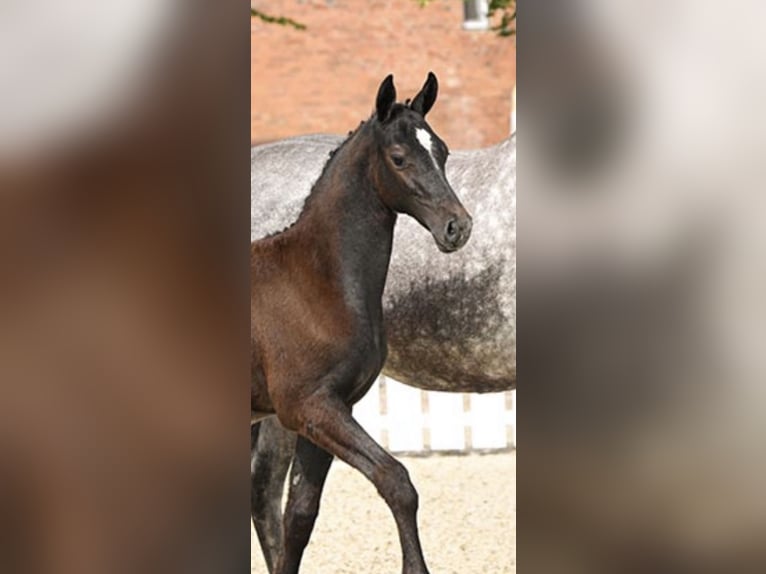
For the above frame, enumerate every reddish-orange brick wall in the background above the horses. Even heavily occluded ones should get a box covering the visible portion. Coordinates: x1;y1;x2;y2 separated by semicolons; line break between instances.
250;0;516;149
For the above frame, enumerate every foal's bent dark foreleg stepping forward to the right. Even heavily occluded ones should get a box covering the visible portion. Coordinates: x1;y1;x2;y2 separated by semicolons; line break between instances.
300;397;428;574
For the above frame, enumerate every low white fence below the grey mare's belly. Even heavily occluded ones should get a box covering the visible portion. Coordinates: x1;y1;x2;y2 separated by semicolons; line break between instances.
354;376;516;454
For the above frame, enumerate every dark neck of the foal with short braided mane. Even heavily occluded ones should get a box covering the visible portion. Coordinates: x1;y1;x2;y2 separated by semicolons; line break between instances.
299;125;396;322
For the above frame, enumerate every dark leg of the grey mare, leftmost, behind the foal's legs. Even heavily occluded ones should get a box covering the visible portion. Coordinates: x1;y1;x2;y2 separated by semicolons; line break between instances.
250;417;295;573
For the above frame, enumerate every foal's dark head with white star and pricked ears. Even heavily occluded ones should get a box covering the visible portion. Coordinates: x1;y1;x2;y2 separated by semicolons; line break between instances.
373;73;471;252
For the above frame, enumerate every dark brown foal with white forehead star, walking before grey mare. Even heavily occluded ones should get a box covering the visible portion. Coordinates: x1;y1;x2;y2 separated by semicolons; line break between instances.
250;74;471;574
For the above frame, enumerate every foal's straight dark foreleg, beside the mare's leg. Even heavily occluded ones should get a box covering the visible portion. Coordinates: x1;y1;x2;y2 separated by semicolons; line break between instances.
276;436;332;574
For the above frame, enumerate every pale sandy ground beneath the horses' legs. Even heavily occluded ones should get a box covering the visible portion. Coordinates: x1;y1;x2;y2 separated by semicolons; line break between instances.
251;452;516;574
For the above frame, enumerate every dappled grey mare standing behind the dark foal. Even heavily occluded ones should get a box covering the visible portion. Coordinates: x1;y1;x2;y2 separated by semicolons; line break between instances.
250;135;516;571
